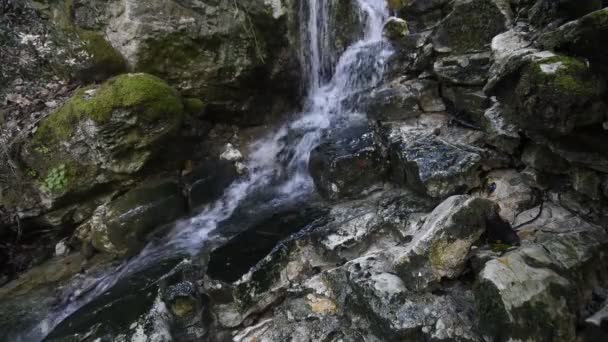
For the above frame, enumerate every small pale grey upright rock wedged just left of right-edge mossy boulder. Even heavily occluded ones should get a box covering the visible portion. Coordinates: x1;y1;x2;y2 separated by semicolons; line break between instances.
481;98;521;154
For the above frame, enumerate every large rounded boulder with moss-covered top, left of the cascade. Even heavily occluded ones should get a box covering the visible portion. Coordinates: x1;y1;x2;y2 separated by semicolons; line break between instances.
23;74;184;197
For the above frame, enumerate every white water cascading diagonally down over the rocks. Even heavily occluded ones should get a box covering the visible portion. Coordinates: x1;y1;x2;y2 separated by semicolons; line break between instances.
17;0;392;341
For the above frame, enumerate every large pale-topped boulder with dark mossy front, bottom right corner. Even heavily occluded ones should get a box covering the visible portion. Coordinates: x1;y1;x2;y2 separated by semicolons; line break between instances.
475;203;608;341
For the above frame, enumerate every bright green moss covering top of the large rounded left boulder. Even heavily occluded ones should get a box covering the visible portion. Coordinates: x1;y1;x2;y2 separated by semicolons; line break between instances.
34;74;183;146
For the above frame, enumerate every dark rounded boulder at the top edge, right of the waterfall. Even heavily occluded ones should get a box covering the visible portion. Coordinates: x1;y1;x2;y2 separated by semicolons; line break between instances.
432;0;506;54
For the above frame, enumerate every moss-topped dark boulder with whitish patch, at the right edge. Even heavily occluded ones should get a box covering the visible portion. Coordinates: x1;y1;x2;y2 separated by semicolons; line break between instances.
514;55;606;135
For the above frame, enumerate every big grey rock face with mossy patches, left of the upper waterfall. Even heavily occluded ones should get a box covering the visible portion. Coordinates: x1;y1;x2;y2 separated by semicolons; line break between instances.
105;0;298;123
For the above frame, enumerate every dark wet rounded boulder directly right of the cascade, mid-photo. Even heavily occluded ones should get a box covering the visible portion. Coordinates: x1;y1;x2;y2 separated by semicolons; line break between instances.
309;125;388;200
